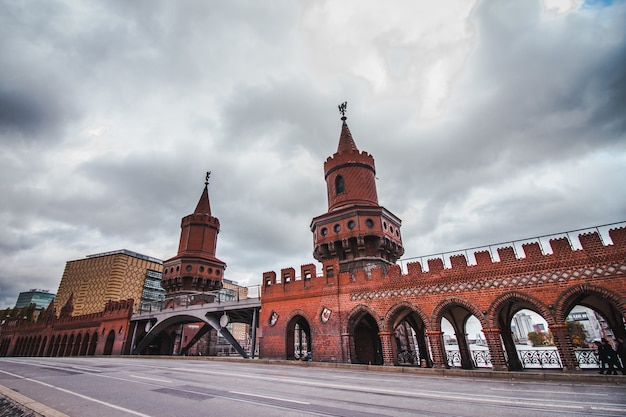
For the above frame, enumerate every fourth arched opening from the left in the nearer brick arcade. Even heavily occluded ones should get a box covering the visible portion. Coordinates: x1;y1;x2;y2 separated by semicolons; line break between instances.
440;304;491;369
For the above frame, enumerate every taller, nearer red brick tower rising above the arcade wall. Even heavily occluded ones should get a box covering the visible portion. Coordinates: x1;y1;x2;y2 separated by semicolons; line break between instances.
311;103;404;272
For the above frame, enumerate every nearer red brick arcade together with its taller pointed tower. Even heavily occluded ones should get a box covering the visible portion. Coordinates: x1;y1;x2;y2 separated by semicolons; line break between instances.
259;107;626;371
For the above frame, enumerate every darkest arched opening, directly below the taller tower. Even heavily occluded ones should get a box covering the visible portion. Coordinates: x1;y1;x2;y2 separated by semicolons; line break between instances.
350;312;383;365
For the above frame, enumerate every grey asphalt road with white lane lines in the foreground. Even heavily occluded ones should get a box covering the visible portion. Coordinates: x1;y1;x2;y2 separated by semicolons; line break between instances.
0;357;626;417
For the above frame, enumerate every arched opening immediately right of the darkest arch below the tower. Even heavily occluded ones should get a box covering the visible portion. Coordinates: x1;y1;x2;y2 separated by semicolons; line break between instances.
390;307;432;367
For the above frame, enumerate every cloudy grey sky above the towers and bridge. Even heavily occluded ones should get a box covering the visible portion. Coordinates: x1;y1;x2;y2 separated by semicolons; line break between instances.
0;0;626;308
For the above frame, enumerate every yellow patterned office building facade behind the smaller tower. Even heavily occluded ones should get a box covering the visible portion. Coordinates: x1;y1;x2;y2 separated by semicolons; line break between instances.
55;249;163;316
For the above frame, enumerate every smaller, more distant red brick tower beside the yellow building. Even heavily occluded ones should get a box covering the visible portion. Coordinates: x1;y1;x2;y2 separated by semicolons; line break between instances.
161;173;226;302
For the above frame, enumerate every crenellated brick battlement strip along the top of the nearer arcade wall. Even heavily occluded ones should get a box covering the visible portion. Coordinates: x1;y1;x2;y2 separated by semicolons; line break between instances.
262;227;626;298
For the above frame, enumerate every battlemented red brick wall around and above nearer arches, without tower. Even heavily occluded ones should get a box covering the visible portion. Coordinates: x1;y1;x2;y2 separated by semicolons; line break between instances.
259;228;626;362
